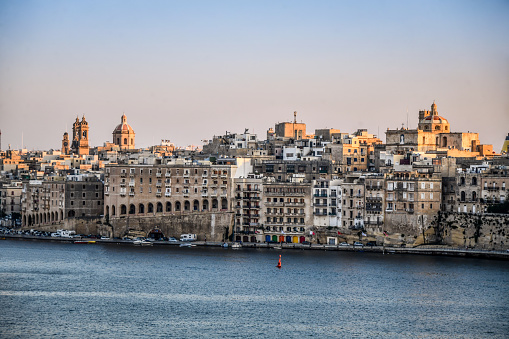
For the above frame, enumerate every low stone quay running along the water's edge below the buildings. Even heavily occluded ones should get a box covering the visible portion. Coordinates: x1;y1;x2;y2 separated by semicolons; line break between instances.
0;234;509;260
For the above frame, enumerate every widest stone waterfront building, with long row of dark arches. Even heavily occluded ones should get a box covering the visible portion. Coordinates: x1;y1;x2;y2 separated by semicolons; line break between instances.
104;163;236;241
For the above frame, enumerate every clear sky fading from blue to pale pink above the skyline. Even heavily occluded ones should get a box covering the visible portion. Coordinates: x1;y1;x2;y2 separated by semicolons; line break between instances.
0;0;509;151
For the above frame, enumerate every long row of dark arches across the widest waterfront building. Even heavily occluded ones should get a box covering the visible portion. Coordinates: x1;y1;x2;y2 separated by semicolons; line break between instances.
106;198;228;216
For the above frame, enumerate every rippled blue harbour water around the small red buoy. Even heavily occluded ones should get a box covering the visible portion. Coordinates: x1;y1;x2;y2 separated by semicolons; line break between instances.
0;240;509;338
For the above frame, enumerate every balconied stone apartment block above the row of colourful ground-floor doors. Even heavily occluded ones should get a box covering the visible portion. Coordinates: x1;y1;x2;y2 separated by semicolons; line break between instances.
257;180;313;243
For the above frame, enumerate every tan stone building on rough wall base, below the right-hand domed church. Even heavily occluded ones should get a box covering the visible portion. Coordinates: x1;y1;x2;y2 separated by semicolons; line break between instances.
385;171;442;235
